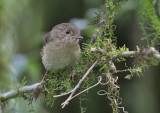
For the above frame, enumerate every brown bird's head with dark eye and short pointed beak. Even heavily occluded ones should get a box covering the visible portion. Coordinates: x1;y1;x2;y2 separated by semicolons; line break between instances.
43;23;83;43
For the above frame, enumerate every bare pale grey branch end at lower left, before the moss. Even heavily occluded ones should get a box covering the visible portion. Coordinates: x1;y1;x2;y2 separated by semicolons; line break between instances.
0;83;41;101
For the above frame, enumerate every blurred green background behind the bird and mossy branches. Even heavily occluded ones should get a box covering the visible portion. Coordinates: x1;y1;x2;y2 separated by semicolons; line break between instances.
0;0;160;113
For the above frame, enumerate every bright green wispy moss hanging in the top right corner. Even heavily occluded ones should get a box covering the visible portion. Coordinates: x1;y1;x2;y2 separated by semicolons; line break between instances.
138;0;160;47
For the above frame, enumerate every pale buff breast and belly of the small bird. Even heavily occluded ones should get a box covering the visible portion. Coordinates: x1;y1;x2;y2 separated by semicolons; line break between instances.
42;42;80;71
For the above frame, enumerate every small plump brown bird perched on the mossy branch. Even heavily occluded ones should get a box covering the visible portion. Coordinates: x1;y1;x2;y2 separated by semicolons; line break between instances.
41;23;83;71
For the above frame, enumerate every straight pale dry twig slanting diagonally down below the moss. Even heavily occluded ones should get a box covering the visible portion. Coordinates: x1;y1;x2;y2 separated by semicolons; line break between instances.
61;60;99;108
